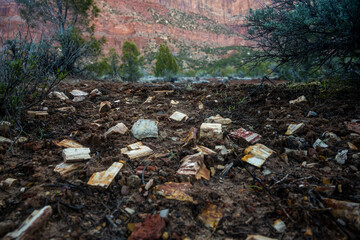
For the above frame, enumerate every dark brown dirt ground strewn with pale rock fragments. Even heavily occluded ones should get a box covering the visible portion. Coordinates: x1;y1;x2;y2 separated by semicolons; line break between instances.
0;80;360;239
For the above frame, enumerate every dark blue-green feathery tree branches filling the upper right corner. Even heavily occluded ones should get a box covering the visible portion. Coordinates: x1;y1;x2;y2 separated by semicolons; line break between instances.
247;0;360;78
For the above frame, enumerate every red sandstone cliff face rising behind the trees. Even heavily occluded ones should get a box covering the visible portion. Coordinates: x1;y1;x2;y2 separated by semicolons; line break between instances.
0;0;264;67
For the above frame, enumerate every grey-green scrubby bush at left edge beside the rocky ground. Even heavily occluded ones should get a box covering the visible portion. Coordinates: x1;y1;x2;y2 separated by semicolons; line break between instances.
0;37;67;137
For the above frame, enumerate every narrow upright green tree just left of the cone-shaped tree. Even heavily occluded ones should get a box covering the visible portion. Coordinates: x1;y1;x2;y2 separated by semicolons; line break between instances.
120;41;144;82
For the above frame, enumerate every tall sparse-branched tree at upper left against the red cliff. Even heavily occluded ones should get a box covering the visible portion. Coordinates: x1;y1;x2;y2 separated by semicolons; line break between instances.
15;0;105;72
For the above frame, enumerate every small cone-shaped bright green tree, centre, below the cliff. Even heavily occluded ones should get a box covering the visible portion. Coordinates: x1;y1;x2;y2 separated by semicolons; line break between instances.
154;44;179;77
